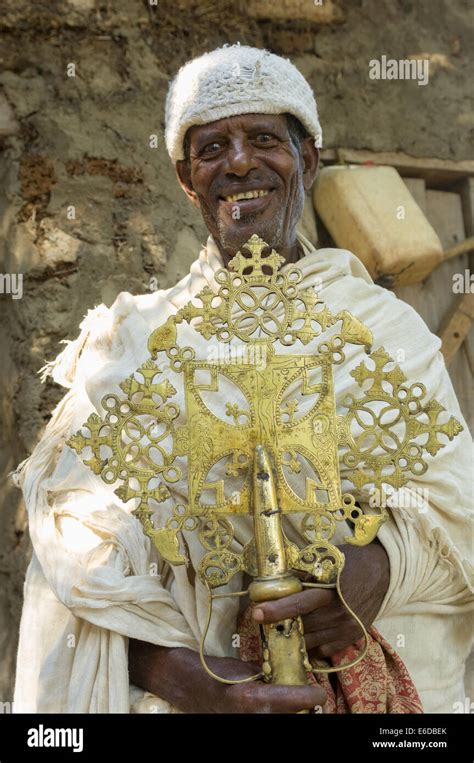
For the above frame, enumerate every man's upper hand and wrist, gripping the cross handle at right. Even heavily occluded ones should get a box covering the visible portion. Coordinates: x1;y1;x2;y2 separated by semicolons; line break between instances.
252;542;390;658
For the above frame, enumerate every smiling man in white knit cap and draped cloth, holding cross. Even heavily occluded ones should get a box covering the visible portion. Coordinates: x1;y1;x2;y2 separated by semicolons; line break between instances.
15;45;472;713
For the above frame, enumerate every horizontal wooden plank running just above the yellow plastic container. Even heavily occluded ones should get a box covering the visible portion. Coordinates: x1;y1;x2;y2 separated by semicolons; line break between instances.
321;148;474;188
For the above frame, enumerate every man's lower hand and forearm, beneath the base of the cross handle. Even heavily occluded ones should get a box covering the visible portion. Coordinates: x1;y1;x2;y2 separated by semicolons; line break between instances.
129;640;326;713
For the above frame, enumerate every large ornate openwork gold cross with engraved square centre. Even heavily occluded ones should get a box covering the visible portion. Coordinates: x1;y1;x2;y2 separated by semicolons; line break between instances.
68;235;462;680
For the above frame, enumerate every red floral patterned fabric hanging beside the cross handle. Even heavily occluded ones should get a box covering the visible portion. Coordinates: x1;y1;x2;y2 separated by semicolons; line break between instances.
238;606;423;713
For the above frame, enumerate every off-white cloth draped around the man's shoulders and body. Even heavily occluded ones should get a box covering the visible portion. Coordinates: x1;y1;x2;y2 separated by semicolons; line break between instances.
14;234;473;713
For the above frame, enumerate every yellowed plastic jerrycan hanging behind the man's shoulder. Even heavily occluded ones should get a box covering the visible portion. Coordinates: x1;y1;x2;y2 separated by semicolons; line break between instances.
313;165;443;286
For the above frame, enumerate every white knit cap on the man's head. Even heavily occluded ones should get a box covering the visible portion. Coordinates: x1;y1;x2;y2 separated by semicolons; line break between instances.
165;43;323;162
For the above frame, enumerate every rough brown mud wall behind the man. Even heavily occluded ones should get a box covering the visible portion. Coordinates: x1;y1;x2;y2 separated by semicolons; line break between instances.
0;0;474;701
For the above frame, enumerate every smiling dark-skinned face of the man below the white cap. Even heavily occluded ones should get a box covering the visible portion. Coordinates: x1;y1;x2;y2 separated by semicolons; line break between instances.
176;114;318;264
